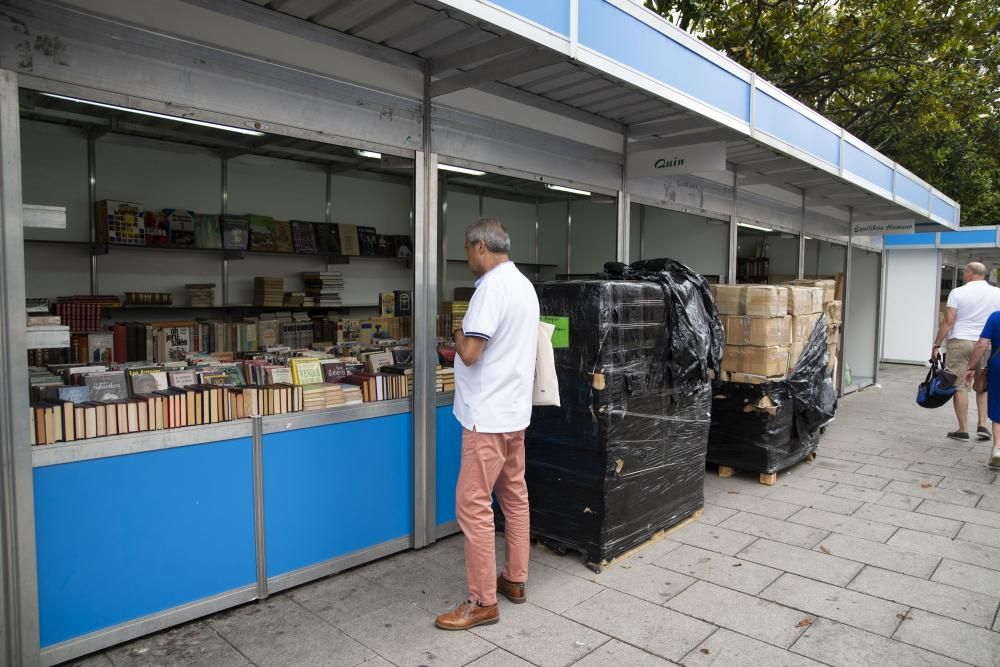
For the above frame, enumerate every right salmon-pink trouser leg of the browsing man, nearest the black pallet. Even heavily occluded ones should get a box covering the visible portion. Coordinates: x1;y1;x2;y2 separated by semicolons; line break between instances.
494;431;531;583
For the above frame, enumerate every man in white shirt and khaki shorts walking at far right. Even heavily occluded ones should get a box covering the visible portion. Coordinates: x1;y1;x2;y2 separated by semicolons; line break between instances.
931;262;1000;442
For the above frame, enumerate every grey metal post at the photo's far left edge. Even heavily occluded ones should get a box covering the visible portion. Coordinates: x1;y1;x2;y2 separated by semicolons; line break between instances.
0;70;39;666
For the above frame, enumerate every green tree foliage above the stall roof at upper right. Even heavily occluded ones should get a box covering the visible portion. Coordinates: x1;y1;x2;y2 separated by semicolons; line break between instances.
646;0;1000;225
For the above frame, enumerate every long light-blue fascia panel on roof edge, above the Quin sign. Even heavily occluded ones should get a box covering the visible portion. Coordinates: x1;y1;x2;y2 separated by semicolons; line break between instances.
580;0;750;122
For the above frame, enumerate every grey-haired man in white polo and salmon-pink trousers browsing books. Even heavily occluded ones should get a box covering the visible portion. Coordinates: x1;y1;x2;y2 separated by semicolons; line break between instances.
435;218;538;630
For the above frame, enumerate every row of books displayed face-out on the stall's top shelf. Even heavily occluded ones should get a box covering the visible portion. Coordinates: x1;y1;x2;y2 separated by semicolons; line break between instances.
97;199;413;257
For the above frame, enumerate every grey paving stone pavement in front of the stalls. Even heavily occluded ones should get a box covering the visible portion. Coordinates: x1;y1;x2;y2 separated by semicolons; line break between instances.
66;365;1000;667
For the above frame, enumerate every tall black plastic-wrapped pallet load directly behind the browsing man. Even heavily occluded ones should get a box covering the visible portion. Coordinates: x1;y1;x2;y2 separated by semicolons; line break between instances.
526;264;722;567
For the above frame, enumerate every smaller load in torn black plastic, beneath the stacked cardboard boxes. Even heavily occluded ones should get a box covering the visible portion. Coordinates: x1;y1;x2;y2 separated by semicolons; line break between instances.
708;315;837;473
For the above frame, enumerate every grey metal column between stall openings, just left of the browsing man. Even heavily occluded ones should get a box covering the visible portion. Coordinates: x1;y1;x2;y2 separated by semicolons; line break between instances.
413;68;443;548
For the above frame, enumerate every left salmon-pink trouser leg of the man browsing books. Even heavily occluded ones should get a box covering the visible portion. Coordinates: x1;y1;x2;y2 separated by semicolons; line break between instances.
455;430;505;605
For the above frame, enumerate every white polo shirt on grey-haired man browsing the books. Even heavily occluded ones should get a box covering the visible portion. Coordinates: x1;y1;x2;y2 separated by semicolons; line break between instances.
454;261;538;433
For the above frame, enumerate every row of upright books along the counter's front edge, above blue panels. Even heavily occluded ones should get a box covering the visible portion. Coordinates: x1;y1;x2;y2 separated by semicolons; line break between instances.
30;385;304;445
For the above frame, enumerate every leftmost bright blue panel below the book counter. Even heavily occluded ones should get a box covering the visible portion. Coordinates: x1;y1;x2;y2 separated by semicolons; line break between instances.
34;438;257;646
